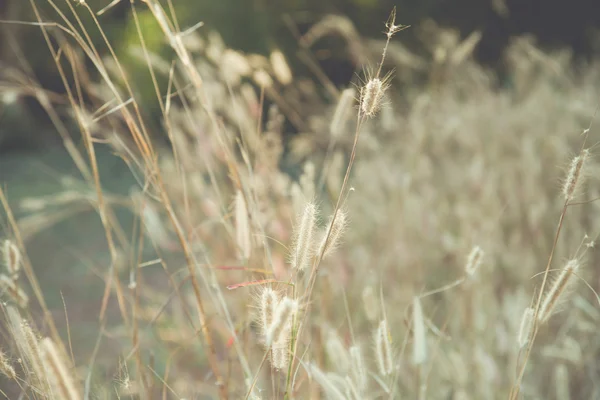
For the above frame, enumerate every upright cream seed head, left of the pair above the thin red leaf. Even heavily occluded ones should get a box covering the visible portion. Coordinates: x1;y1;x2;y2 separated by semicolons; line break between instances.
291;202;317;271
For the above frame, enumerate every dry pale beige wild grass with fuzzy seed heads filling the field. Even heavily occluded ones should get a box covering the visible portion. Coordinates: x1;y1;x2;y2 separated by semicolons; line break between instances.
0;0;600;400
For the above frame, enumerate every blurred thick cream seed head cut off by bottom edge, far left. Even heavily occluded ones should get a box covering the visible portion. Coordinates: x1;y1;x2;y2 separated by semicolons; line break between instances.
40;338;81;400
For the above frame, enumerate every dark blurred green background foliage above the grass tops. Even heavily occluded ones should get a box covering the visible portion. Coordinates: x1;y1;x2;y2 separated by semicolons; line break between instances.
0;0;600;152
